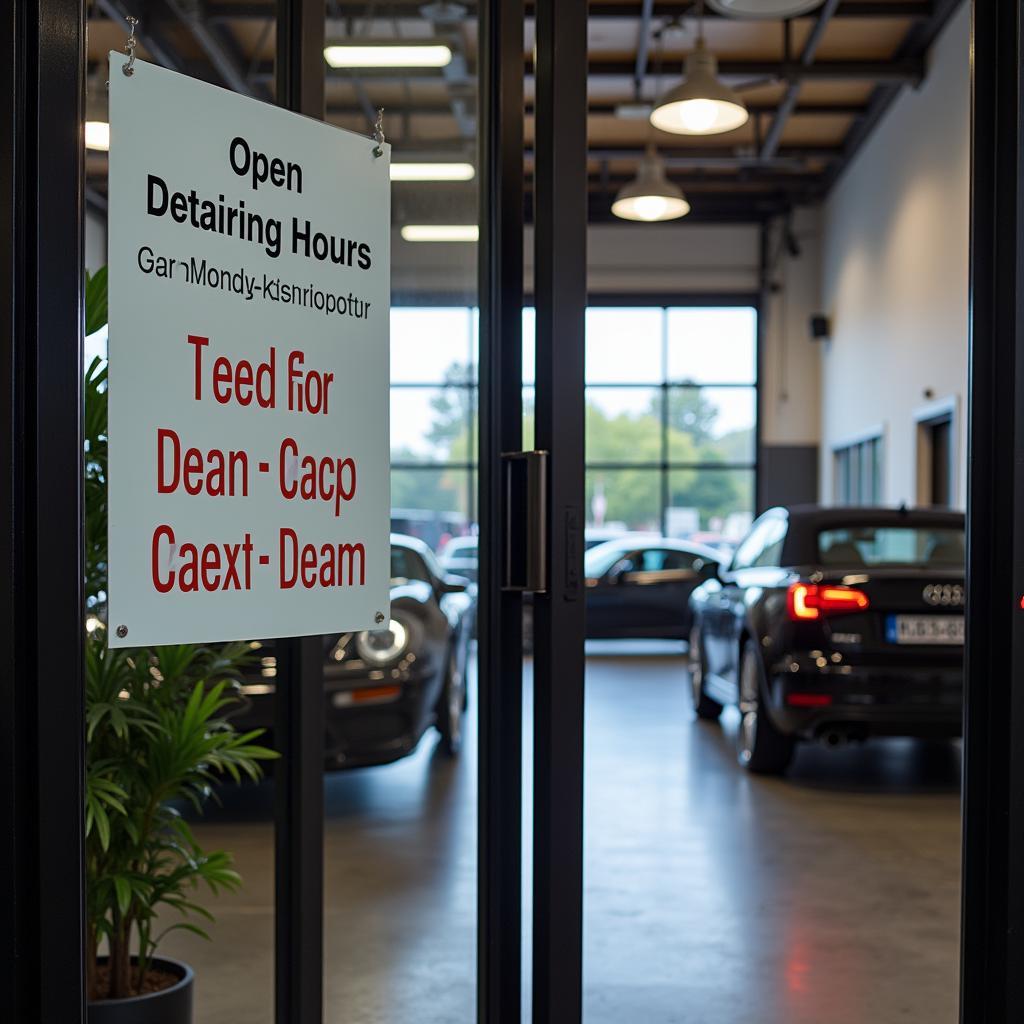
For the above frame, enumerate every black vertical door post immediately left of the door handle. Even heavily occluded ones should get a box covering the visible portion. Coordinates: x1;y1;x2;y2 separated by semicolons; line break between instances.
477;0;523;1024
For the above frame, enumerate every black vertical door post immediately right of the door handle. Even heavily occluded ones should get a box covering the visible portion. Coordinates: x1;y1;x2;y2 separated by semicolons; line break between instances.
534;0;588;1024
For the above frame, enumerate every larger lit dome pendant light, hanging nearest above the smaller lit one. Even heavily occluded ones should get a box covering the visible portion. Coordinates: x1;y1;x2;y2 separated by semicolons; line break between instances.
650;3;750;135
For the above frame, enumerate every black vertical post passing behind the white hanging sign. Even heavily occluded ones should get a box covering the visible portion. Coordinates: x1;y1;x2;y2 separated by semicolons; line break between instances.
274;0;325;1024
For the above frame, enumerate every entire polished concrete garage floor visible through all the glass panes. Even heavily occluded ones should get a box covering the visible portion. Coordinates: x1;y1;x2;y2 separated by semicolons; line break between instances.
165;644;959;1024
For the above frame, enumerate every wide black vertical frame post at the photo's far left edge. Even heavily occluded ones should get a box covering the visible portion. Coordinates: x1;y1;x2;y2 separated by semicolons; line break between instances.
0;0;85;1024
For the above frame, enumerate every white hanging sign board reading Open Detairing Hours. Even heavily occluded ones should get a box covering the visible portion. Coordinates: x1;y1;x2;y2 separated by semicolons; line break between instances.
108;53;390;647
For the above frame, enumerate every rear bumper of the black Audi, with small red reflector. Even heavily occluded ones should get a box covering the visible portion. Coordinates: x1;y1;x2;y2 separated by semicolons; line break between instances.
769;655;964;739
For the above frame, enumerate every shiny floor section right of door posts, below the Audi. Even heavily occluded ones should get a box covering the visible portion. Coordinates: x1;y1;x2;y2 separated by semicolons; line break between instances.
585;643;959;1024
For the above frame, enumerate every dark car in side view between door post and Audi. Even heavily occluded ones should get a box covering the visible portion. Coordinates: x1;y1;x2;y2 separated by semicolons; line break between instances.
583;535;720;640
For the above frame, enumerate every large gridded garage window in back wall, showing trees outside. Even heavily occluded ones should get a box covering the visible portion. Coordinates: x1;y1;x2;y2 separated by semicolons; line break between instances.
391;304;758;550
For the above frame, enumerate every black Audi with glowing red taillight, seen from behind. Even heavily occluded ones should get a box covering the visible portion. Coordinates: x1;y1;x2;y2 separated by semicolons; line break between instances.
689;506;965;773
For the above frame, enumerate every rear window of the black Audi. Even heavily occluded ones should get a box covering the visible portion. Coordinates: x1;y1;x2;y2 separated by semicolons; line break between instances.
818;525;966;569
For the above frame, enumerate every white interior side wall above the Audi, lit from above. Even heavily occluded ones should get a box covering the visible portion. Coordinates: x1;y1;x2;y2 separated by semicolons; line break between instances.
821;4;970;507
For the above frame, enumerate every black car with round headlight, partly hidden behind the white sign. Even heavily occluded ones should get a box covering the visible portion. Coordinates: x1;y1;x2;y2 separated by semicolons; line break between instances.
232;535;476;768
